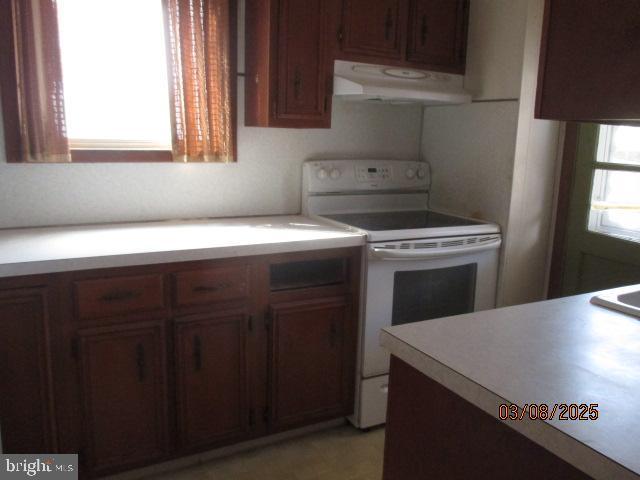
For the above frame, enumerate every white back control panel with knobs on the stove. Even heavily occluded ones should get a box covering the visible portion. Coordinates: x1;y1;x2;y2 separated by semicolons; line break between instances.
303;160;429;193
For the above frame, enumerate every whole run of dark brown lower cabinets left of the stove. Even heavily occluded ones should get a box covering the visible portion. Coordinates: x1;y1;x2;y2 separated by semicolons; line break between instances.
0;248;362;478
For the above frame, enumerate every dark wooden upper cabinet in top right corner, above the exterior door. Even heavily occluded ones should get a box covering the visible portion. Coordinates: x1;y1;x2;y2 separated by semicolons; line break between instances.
536;0;640;121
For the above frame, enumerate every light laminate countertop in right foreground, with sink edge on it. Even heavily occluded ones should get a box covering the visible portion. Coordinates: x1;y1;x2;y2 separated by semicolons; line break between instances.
380;286;640;479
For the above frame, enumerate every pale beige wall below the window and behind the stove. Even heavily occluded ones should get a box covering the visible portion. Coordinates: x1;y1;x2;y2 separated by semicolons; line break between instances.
0;2;422;228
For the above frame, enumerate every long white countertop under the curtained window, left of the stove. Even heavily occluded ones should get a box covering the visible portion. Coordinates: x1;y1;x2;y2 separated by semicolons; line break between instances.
0;215;364;277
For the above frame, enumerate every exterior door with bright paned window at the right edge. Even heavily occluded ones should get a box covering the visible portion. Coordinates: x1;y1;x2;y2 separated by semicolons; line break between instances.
562;124;640;295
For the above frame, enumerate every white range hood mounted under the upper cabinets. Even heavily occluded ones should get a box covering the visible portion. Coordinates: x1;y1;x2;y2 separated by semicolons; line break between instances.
333;60;471;105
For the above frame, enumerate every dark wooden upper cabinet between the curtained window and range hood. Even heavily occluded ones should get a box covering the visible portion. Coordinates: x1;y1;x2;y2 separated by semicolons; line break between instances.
245;0;333;128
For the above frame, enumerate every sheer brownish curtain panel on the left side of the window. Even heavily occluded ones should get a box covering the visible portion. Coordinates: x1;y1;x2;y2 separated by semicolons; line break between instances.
12;0;71;162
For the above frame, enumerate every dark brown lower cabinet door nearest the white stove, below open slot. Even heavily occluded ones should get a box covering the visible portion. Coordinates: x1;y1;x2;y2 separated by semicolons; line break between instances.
270;297;354;431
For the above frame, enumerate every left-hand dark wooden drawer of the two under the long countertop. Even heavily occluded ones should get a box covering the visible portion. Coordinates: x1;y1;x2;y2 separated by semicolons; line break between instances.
75;275;164;319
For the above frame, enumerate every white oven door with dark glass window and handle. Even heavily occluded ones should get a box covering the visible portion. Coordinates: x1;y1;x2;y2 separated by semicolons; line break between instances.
360;234;501;378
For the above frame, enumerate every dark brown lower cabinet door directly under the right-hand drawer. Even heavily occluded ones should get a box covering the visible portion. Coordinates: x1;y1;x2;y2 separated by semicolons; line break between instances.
175;313;250;449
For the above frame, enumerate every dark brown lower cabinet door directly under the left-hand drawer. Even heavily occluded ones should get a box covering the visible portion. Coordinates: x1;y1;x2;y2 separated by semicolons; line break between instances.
79;322;167;473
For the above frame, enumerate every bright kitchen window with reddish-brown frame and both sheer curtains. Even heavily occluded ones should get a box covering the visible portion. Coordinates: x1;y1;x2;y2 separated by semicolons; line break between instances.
0;0;236;163
